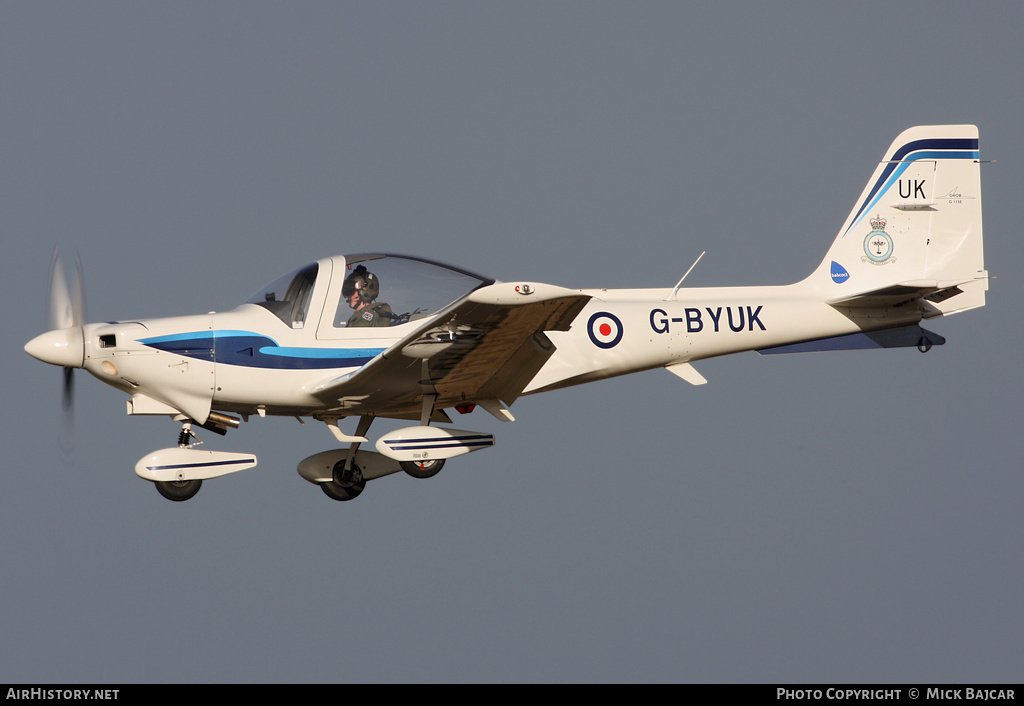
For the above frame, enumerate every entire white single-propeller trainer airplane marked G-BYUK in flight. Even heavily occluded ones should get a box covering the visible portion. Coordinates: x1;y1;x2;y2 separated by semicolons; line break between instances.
25;125;988;501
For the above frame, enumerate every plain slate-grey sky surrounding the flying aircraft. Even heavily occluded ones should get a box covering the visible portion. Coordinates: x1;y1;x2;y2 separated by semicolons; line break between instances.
0;2;1024;682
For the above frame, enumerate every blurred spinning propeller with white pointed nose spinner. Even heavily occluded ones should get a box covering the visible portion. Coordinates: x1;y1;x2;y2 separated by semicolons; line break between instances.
25;248;85;452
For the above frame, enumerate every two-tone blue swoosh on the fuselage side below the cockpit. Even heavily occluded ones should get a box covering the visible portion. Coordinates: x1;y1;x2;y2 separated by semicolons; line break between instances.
138;331;385;370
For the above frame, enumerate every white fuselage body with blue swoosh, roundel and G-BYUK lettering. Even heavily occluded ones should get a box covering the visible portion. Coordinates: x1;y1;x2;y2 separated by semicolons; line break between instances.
74;274;926;422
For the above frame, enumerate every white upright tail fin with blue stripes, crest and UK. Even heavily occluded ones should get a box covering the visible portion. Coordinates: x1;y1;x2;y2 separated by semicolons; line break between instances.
810;125;988;318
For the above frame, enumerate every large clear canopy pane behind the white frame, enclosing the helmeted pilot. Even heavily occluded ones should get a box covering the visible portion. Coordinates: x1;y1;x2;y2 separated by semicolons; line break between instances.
334;255;494;328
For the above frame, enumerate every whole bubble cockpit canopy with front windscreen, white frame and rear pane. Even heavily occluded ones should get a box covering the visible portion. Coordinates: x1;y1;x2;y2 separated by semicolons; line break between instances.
246;254;494;329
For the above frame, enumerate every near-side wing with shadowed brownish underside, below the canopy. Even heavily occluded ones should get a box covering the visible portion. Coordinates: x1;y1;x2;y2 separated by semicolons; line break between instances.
312;283;590;418
